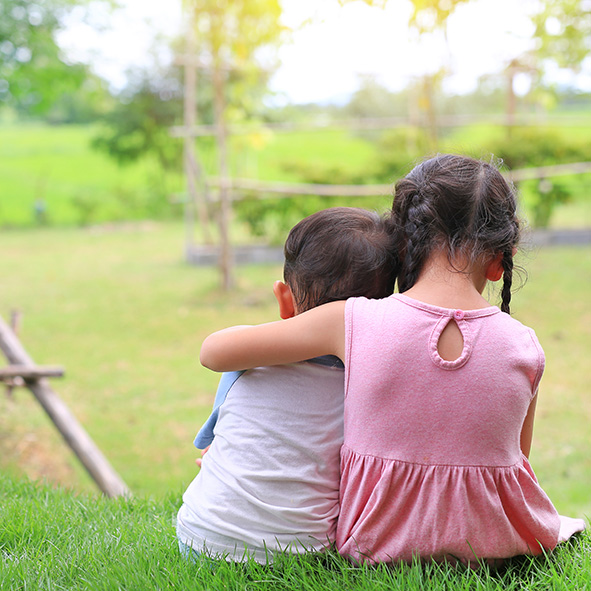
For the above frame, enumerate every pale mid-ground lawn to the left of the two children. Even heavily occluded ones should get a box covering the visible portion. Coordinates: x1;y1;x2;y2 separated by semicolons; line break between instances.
0;225;281;493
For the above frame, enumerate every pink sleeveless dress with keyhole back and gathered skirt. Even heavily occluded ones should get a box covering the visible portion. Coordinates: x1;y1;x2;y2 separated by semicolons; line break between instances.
337;294;584;562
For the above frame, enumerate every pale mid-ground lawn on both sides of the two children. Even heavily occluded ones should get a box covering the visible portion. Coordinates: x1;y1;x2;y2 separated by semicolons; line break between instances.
0;223;591;516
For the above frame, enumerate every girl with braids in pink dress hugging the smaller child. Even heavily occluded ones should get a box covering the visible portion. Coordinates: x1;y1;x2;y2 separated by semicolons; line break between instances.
201;155;584;563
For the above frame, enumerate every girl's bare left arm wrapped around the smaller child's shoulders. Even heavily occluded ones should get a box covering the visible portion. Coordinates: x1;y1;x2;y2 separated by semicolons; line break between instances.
200;301;345;371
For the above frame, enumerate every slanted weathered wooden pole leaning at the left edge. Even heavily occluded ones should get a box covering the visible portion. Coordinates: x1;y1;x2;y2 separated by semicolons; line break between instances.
0;318;131;497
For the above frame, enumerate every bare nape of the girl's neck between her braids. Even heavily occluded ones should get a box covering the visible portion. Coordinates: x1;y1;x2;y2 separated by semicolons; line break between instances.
404;253;490;310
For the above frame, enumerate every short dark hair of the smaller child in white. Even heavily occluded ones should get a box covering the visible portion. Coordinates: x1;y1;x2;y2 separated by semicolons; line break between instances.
283;207;398;312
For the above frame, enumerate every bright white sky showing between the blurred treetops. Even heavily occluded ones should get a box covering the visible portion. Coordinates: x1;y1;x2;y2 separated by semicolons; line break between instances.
61;0;591;103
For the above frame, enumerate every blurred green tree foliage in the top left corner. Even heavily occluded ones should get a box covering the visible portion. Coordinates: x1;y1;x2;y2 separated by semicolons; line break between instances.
0;0;95;115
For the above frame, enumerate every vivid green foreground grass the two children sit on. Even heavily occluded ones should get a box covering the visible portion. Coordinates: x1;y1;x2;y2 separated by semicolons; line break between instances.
0;475;591;591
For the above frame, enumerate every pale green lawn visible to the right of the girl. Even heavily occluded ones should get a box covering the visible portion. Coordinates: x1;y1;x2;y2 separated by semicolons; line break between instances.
514;246;591;516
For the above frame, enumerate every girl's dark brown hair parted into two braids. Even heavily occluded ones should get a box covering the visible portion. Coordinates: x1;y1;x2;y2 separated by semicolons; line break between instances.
392;154;520;313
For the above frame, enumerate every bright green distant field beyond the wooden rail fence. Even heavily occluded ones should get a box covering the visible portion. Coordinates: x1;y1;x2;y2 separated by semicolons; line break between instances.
0;124;591;227
